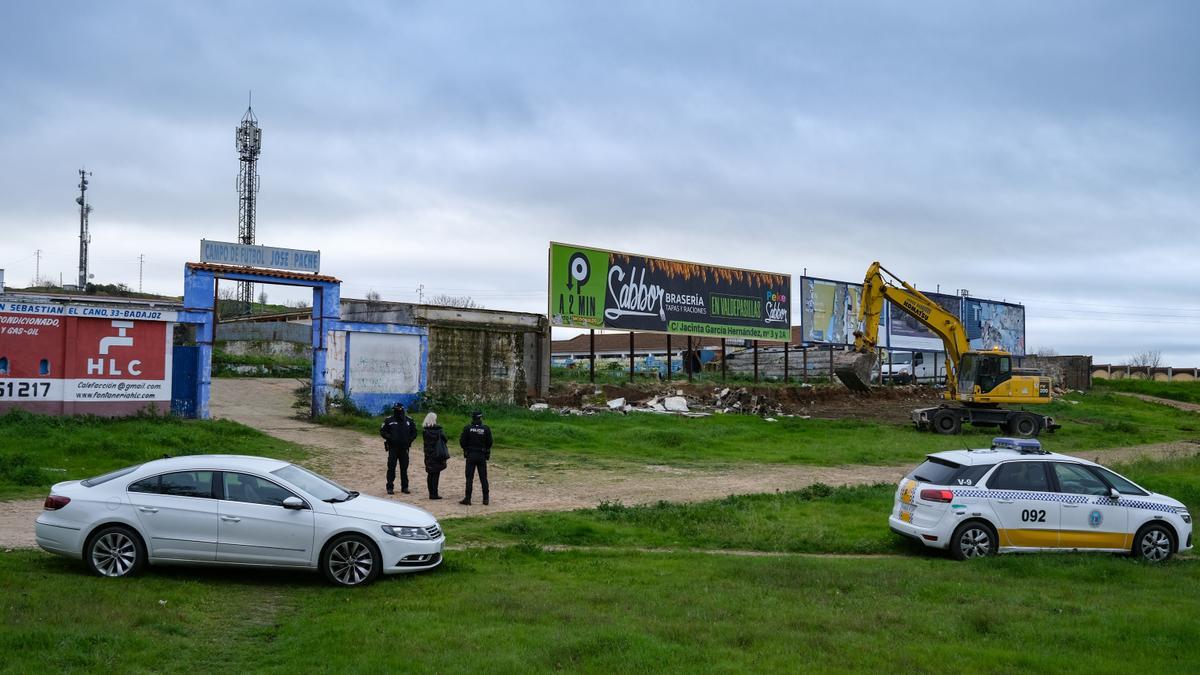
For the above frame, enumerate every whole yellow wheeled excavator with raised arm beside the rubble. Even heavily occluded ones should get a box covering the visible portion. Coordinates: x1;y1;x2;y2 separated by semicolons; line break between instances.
835;257;1060;438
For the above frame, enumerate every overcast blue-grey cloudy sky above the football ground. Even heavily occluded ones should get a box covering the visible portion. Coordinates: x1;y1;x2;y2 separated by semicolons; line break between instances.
0;0;1200;368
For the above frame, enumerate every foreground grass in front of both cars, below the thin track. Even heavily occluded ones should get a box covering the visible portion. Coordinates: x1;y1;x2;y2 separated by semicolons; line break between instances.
0;546;1200;673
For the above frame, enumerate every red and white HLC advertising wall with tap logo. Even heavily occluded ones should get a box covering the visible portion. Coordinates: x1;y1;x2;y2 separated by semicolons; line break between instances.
0;305;172;416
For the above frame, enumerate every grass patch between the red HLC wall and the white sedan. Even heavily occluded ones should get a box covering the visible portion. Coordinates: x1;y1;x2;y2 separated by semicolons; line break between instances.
0;411;305;500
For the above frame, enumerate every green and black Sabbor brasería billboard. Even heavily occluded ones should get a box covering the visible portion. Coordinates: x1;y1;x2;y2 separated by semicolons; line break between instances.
548;243;792;341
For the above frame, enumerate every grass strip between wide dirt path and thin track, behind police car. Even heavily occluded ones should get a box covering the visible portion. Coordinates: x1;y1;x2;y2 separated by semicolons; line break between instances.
445;455;1200;554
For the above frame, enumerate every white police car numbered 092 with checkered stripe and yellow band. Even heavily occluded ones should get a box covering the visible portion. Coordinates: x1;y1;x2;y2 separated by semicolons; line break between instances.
888;438;1192;562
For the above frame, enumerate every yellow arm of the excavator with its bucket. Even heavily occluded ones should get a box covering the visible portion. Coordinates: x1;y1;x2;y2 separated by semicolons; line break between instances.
836;262;971;398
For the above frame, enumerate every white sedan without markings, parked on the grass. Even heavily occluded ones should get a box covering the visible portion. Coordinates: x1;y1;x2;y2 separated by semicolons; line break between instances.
37;455;445;586
